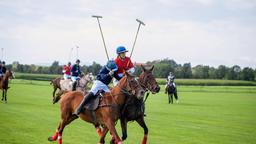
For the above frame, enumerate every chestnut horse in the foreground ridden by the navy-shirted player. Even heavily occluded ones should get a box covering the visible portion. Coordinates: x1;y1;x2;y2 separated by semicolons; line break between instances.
48;73;145;144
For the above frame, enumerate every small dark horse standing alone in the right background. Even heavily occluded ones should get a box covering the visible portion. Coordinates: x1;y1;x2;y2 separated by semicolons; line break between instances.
165;82;179;104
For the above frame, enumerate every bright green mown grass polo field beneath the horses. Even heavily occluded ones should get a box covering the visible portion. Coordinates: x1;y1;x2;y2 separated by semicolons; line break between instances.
0;80;256;144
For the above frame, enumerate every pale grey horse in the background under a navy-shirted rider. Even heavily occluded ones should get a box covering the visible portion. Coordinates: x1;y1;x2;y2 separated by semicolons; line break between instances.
51;73;93;104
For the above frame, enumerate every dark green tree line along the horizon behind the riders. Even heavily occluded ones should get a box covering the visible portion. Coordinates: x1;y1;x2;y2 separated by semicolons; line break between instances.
7;58;256;81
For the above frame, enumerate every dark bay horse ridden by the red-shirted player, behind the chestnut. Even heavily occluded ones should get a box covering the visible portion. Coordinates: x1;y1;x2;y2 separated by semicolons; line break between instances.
102;65;160;144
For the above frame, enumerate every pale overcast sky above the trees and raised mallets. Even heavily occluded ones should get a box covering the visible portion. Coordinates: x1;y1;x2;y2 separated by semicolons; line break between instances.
0;0;256;68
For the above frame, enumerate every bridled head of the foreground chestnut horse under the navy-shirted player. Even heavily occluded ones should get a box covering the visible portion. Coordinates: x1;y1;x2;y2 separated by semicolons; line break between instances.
117;72;145;99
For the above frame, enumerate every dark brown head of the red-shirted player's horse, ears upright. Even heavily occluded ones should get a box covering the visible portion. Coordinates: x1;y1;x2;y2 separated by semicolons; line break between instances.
139;65;160;94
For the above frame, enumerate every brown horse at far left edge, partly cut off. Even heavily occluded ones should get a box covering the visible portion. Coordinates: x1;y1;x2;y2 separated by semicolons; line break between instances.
0;70;14;103
